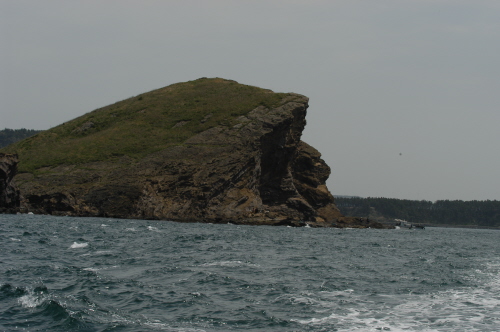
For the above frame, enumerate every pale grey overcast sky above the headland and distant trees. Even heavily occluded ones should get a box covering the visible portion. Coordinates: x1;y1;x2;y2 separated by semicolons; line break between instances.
0;0;500;201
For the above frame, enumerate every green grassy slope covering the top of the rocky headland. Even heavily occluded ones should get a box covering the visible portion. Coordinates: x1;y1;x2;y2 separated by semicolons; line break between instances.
0;78;286;174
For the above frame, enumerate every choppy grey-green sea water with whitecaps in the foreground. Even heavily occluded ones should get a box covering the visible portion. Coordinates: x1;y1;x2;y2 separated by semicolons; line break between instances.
0;215;500;331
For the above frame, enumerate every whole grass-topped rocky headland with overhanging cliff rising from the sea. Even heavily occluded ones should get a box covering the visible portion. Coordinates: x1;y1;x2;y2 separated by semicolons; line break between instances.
2;78;390;228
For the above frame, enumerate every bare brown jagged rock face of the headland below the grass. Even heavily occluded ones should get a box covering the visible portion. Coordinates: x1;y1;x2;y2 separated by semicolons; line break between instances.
16;95;341;225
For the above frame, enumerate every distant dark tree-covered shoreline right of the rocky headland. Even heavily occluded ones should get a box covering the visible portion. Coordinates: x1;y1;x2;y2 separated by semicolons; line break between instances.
335;196;500;227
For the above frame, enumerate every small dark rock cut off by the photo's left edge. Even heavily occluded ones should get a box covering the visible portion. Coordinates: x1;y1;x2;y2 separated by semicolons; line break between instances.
0;153;20;213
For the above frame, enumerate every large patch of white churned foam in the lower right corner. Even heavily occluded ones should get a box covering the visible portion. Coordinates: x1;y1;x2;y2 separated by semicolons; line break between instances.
290;284;500;332
